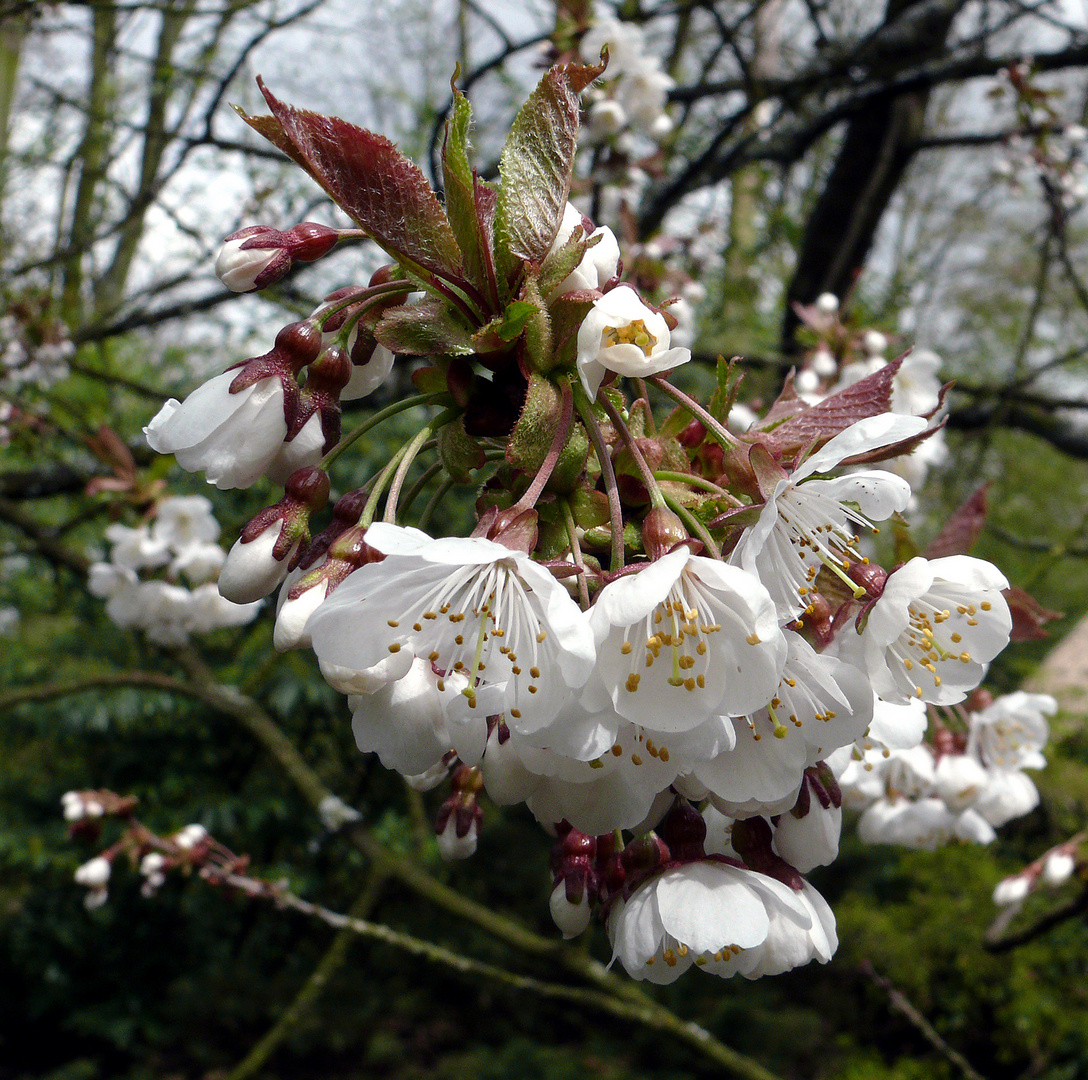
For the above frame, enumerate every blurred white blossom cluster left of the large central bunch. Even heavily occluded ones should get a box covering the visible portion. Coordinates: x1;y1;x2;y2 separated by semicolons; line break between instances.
87;495;260;645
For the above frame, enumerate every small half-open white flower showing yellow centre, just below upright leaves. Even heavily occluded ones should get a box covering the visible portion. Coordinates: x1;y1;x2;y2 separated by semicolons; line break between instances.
578;284;691;398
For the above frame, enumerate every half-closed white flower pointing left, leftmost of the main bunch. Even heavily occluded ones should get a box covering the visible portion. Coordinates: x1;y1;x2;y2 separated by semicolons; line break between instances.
144;371;287;489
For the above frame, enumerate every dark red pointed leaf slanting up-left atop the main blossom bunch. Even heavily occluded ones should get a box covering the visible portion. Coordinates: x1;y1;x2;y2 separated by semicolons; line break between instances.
242;79;462;281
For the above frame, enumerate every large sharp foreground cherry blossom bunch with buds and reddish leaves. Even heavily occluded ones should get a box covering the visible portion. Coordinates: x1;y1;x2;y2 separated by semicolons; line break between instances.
136;65;1024;982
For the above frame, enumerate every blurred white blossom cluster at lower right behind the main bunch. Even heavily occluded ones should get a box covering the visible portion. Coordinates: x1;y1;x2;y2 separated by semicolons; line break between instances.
829;692;1058;848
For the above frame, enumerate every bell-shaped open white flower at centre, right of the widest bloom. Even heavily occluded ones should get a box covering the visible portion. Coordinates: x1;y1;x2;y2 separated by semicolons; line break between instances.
583;546;787;732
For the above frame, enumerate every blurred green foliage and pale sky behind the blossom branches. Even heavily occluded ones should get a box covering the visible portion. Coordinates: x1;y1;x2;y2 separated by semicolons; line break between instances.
6;0;1088;1080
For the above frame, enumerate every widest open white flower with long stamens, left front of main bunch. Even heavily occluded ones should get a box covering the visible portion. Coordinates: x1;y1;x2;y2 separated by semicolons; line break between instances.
308;523;594;735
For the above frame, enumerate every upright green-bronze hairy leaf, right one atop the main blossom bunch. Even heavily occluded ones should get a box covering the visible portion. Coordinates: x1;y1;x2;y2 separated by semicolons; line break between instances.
495;64;604;276
